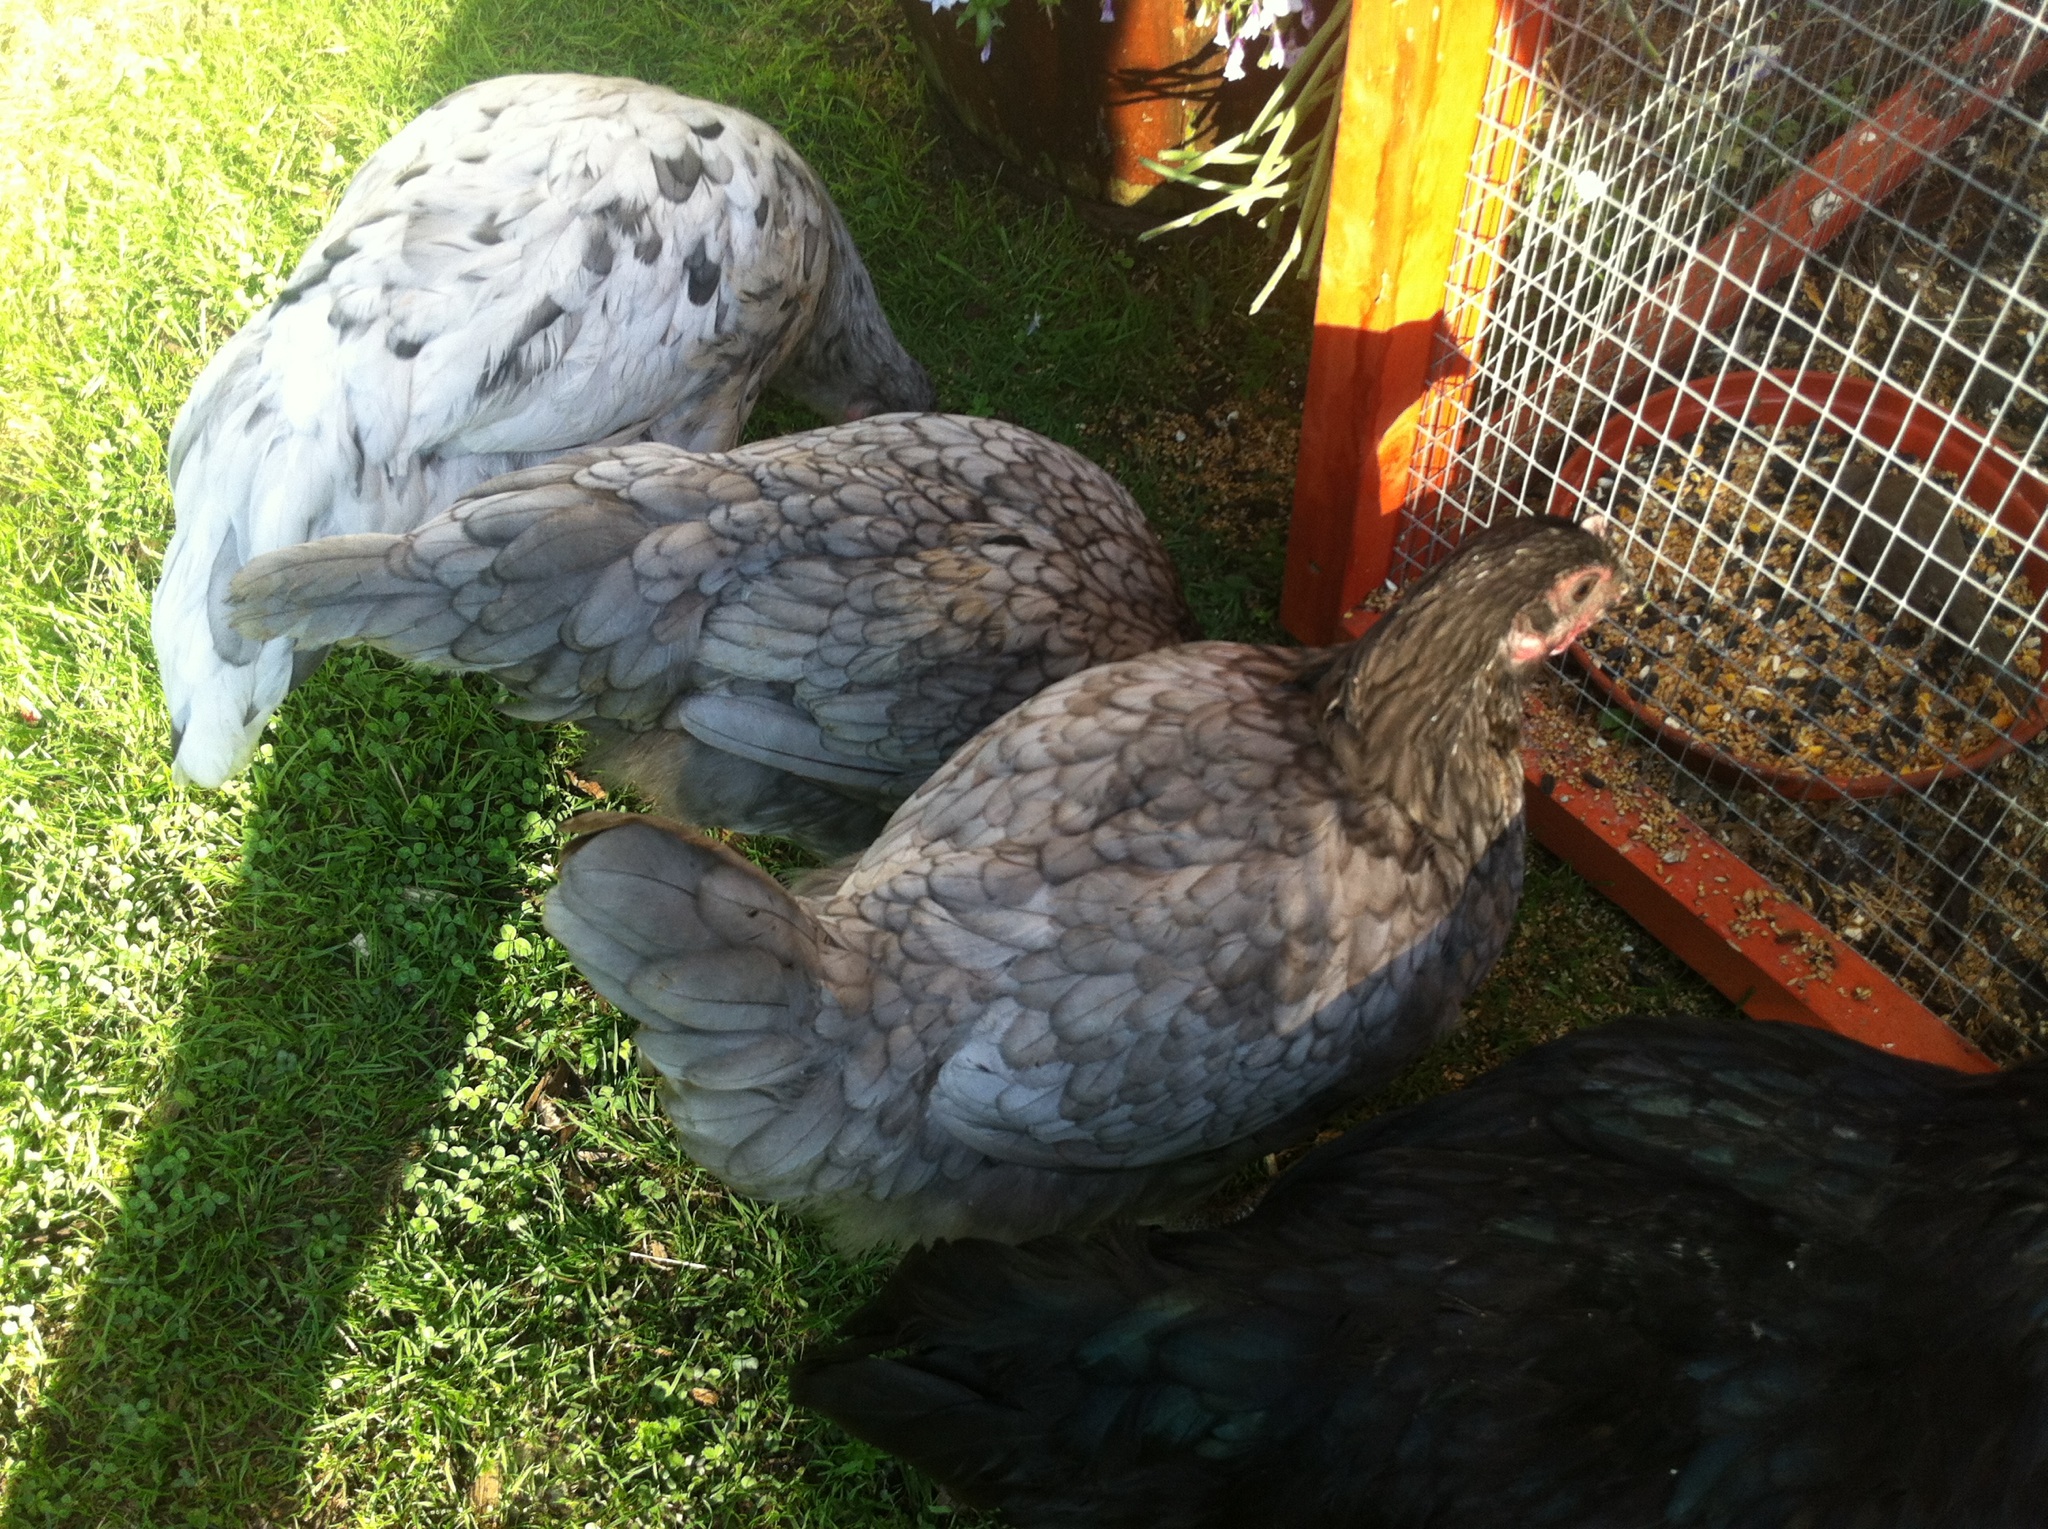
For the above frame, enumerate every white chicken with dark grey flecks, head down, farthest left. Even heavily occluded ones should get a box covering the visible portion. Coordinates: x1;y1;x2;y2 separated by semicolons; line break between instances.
152;74;934;786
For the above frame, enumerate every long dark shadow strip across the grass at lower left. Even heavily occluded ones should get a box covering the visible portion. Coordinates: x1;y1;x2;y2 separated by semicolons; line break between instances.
0;655;559;1529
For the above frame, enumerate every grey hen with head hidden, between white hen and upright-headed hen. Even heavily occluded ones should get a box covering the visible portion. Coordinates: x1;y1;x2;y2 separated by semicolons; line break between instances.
229;413;1194;856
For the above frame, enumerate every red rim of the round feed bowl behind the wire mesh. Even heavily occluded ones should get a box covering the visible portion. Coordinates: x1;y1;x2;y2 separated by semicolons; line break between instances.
1550;370;2048;802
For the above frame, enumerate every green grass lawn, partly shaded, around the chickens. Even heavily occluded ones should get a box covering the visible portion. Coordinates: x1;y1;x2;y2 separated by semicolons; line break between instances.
0;0;1728;1529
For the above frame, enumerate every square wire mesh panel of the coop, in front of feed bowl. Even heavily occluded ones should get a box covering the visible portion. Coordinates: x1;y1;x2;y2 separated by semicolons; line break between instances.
1395;0;2048;1058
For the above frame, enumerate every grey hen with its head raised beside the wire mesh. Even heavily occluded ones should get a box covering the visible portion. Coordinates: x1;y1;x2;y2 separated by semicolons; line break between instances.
547;518;1622;1244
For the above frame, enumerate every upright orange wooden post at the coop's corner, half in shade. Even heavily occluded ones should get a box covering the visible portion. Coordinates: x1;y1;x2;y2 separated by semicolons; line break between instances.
1280;0;1520;643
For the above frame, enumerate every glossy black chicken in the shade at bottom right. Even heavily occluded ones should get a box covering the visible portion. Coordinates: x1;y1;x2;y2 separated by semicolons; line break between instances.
793;1019;2048;1529
